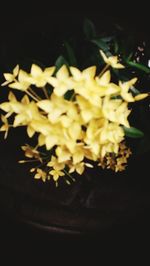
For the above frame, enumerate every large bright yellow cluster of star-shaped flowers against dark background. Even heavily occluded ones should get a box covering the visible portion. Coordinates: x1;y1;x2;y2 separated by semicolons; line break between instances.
0;51;147;182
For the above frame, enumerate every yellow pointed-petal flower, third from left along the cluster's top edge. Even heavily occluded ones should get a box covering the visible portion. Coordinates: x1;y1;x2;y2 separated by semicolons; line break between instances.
30;64;55;88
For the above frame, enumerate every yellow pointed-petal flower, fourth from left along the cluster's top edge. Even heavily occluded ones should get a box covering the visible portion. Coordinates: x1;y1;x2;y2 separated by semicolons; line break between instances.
48;65;73;96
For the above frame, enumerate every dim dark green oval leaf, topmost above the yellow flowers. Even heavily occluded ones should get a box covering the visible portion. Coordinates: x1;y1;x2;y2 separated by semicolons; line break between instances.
83;18;96;40
